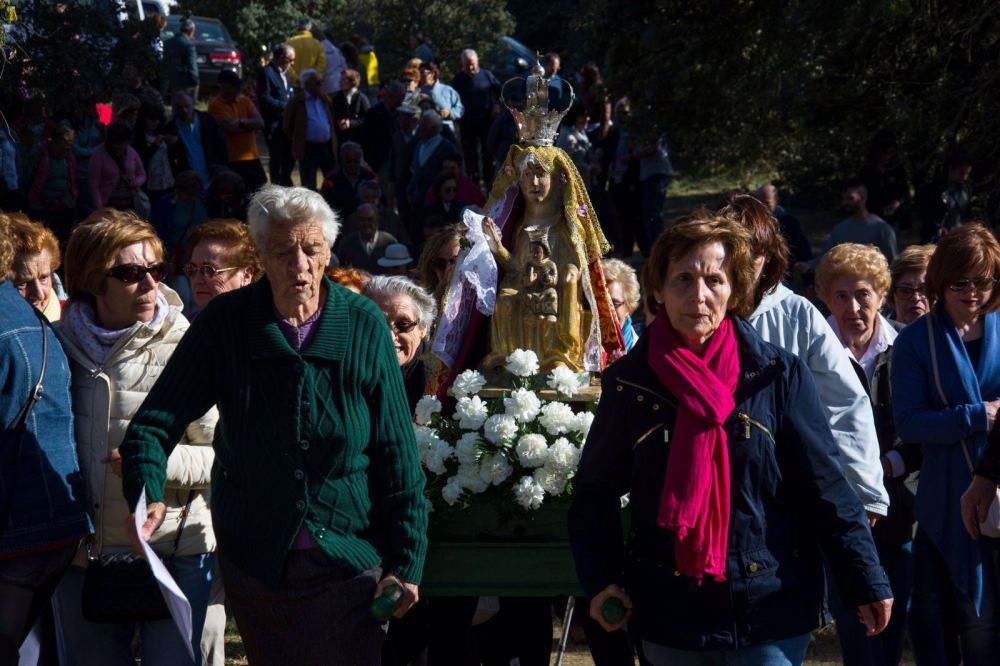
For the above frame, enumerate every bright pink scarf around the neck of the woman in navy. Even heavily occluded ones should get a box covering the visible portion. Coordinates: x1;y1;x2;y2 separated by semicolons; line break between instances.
649;308;740;583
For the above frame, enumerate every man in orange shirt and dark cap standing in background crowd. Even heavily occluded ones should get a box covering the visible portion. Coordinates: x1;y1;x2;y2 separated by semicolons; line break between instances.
208;70;267;193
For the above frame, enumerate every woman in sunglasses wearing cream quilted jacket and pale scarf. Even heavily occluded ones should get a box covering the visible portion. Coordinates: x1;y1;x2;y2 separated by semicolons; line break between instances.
51;210;217;666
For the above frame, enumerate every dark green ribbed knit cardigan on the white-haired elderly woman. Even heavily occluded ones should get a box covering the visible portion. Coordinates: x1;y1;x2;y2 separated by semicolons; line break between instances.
120;278;427;584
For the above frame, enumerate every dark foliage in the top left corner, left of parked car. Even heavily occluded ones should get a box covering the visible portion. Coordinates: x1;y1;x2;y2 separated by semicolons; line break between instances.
0;0;158;111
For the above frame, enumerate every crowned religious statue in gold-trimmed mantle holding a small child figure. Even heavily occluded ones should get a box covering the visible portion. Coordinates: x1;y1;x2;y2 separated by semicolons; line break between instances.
431;67;624;390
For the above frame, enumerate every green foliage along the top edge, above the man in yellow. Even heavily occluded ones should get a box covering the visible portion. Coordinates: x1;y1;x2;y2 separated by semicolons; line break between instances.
181;0;514;78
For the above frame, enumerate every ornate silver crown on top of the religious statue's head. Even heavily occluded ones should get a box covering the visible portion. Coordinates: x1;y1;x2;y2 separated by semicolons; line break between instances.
500;61;576;146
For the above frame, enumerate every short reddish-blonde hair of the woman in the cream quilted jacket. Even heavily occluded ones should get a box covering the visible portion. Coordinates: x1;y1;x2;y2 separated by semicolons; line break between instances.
64;208;163;304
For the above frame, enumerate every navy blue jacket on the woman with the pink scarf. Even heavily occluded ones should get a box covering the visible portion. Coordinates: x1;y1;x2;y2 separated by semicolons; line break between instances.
569;320;892;650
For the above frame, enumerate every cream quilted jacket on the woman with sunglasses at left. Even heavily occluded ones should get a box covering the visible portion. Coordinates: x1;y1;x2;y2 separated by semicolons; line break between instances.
57;284;218;566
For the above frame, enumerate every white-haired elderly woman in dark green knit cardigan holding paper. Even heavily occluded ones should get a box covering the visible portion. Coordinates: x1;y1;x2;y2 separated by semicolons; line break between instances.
121;186;427;664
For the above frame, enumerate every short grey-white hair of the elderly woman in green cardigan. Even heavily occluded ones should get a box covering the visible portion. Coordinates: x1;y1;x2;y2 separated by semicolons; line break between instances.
247;185;340;249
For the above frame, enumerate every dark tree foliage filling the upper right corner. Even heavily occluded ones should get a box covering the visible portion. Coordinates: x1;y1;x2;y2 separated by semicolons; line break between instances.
580;0;1000;187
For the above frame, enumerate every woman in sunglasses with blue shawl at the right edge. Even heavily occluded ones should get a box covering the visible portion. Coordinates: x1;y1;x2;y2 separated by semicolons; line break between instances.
891;224;1000;666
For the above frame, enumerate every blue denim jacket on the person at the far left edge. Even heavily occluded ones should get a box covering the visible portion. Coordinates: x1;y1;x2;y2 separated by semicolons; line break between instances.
0;280;90;556
